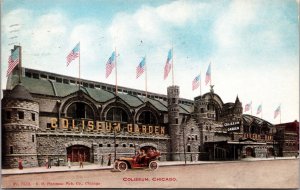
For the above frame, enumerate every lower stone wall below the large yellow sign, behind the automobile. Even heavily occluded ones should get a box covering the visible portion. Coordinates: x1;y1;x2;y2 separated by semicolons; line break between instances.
37;133;169;166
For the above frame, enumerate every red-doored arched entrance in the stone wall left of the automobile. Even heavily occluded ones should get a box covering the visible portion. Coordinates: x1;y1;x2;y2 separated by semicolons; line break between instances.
67;145;90;162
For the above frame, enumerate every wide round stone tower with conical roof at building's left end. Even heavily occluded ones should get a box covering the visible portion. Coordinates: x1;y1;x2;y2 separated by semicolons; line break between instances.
2;84;39;168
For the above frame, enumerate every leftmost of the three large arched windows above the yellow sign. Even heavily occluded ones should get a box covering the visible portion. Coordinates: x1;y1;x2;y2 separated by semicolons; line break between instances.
67;102;94;119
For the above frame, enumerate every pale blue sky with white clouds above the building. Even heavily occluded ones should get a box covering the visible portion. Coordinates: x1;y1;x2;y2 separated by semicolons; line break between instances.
1;0;299;124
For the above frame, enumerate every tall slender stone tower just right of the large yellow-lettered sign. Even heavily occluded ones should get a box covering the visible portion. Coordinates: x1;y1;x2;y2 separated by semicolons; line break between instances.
168;86;182;161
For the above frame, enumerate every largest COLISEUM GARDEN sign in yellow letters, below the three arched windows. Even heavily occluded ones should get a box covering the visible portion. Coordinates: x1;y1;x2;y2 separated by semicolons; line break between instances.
50;118;165;135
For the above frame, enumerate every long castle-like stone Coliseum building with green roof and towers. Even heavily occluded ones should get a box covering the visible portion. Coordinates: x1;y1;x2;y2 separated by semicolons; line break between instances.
2;65;286;168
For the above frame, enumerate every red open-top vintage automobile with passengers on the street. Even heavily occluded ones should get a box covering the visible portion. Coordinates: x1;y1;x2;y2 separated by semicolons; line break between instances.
114;149;160;171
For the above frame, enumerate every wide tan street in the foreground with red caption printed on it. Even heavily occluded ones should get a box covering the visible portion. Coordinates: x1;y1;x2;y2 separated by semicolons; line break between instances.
2;159;299;189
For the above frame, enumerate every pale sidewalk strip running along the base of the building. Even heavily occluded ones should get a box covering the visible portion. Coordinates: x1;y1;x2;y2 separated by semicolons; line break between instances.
2;157;299;175
